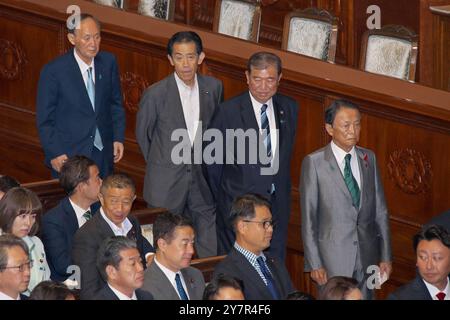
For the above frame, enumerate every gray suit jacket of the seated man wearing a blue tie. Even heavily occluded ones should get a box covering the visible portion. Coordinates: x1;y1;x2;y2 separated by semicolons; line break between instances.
141;262;205;300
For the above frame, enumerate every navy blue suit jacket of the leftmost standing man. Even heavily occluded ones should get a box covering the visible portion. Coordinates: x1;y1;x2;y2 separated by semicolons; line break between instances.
36;50;125;176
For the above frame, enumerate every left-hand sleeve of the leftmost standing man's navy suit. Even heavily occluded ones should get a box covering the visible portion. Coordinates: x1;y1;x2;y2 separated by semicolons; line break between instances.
36;66;66;160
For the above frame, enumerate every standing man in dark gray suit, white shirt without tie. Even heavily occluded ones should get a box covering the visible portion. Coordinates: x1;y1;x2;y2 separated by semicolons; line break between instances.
136;31;223;257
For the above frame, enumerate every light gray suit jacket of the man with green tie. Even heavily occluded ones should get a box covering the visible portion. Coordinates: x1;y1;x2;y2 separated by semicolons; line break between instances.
300;144;392;277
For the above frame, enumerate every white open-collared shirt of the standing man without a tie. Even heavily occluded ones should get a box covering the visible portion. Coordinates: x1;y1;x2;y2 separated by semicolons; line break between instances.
174;72;200;146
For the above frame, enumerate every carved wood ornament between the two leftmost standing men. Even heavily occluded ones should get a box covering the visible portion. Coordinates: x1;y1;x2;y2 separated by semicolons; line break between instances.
120;72;149;113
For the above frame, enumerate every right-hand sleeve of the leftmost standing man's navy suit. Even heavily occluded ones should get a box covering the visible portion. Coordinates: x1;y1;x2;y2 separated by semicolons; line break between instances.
111;58;126;143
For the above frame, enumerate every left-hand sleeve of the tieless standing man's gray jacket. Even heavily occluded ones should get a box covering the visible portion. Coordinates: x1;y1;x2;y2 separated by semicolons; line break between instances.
136;90;158;162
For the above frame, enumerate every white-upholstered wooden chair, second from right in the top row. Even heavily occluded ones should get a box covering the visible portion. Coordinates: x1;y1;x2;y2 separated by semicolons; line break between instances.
281;8;338;62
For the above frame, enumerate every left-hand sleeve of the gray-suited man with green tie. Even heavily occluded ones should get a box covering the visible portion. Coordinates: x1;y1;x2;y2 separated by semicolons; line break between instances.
300;156;323;272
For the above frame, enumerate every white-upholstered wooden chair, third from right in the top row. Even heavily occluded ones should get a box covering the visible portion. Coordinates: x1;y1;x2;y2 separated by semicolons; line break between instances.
213;0;261;42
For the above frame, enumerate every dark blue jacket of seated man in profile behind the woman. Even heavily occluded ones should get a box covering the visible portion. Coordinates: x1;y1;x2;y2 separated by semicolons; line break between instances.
41;197;78;281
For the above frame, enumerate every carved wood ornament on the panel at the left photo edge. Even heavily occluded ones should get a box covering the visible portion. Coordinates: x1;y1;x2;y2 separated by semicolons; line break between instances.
0;39;28;80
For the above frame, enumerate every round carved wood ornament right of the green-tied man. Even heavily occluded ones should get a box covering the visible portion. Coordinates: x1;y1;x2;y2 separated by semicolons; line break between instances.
388;149;433;194
